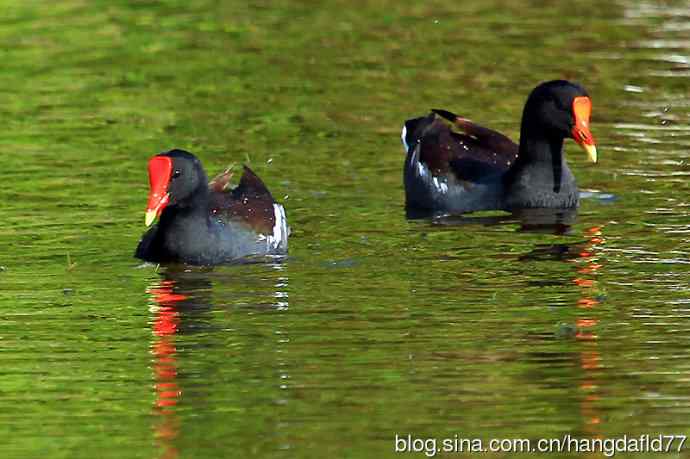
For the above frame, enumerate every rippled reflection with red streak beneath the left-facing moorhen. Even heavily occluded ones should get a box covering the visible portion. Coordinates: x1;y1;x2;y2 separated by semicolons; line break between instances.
147;263;288;459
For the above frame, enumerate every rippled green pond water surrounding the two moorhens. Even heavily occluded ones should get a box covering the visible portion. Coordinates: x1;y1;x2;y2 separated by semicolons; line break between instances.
0;0;690;459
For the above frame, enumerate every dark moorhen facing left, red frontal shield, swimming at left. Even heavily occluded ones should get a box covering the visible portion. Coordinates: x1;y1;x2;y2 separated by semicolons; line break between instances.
135;150;289;265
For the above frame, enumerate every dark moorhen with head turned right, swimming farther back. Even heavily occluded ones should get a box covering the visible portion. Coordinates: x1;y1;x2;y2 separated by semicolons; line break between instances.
402;80;597;214
